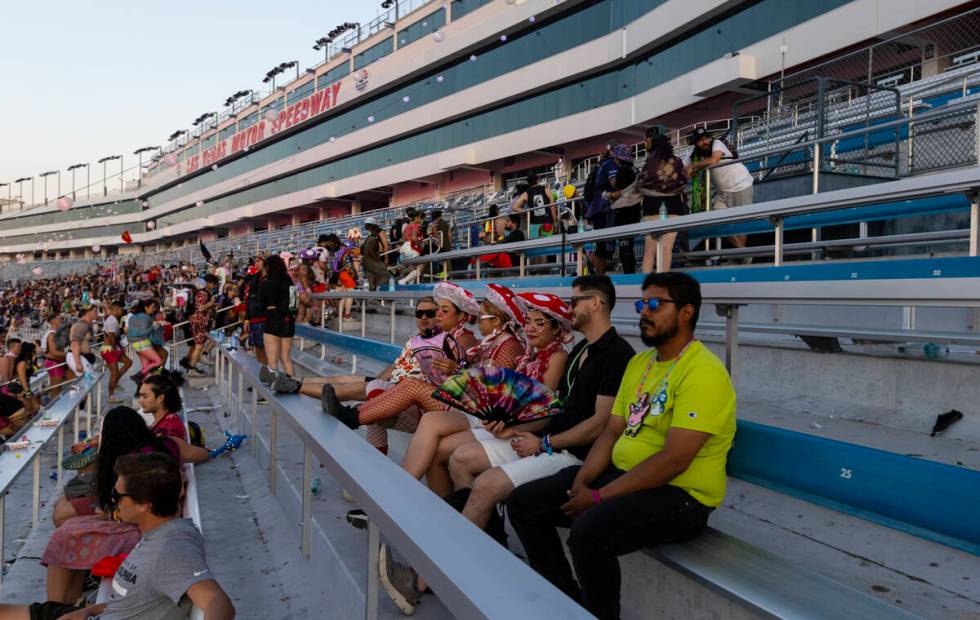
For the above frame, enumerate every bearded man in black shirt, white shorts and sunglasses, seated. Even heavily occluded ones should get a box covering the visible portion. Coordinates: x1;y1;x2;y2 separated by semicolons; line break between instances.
440;276;634;527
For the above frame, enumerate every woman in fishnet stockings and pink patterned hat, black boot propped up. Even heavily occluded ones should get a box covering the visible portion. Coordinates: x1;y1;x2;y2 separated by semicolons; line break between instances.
321;282;480;429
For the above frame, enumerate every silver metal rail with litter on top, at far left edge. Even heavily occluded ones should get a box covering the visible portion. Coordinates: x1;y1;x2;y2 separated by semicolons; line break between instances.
0;372;104;582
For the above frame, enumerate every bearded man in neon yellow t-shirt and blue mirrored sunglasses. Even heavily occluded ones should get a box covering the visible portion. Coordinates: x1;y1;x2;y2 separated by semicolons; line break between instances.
507;272;735;619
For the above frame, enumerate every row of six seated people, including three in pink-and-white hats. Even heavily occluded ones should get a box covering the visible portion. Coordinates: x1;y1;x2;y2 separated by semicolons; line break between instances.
260;260;735;618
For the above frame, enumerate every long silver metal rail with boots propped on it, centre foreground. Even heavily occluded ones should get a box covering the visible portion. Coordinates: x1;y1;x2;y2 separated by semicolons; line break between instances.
215;346;591;620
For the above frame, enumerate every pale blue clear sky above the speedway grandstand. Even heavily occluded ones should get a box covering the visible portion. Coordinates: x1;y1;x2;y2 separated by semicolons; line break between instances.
0;0;381;200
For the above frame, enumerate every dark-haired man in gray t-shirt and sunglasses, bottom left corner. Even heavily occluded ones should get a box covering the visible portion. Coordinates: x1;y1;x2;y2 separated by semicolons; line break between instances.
0;453;235;620
